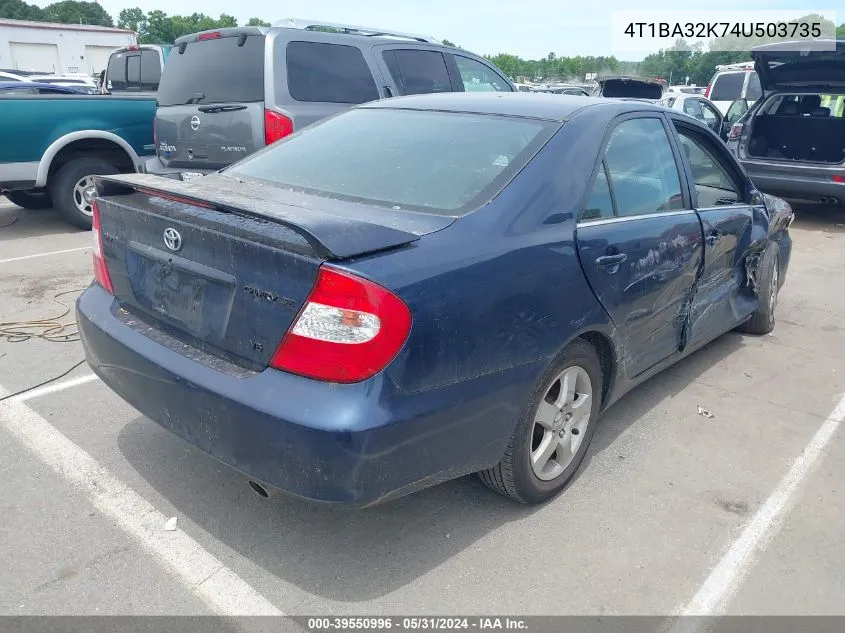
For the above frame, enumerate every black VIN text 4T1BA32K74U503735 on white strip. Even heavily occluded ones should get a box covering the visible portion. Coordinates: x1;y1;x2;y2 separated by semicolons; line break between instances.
624;22;822;39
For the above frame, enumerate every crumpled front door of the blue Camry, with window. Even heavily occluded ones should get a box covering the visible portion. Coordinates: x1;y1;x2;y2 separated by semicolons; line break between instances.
673;118;768;347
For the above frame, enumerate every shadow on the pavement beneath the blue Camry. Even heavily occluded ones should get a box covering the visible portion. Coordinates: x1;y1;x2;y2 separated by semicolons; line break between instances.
118;334;742;602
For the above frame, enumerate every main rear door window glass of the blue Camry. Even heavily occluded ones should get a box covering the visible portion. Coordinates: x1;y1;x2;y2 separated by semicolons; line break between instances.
605;118;684;216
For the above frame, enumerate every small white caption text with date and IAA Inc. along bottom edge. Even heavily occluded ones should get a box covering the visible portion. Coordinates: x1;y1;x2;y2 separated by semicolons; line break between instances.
305;616;528;631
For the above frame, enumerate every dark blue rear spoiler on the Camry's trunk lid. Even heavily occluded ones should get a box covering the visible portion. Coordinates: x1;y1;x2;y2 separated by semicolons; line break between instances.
94;174;419;259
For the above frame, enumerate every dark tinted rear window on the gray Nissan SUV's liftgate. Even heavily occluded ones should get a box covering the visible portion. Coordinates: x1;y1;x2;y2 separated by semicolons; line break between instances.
158;35;264;106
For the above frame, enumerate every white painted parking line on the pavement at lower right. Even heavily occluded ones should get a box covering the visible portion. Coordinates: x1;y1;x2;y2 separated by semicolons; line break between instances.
680;395;845;620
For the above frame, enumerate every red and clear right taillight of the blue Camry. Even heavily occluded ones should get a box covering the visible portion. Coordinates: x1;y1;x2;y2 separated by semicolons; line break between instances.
270;266;411;383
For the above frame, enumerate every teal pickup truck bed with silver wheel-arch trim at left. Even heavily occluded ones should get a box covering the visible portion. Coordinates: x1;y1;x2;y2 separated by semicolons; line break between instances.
0;95;156;229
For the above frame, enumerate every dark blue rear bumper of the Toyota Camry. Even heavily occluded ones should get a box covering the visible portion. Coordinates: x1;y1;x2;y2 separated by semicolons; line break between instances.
77;284;528;506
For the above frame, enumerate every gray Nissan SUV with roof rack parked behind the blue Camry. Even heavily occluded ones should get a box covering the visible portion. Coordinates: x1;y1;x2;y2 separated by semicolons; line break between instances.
144;20;516;180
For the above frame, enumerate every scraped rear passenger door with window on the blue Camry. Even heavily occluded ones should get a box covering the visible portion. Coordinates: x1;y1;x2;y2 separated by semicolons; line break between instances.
576;115;702;379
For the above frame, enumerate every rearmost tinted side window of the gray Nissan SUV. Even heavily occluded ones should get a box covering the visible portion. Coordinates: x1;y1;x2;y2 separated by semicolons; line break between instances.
287;42;379;103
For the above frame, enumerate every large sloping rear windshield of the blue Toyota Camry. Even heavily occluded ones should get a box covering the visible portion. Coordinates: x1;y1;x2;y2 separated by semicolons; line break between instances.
226;108;559;215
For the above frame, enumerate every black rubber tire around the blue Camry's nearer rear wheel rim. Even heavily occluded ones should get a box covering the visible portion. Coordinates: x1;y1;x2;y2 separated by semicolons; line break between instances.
478;339;604;505
